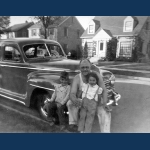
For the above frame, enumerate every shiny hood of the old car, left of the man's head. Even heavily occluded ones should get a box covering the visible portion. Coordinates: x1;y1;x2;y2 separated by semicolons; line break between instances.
30;59;79;71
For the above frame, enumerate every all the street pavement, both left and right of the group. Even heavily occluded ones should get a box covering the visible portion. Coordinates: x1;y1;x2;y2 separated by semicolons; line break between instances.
0;79;150;133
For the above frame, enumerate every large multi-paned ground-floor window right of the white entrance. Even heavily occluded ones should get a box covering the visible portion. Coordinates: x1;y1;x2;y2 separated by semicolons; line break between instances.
120;41;132;57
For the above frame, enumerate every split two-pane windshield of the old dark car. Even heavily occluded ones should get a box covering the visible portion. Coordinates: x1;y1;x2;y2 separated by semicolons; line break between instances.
23;44;64;58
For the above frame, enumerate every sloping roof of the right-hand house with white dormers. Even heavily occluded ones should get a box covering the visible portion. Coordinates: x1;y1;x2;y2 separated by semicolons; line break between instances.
81;16;148;38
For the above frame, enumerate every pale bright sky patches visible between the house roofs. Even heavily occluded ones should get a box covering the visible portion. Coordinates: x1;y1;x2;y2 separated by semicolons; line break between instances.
10;16;94;29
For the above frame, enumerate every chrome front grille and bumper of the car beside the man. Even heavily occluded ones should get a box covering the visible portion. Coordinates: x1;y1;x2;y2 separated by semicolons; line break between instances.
103;76;121;111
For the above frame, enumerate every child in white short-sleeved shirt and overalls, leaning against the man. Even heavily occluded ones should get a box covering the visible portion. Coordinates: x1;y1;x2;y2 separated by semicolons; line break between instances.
78;72;102;133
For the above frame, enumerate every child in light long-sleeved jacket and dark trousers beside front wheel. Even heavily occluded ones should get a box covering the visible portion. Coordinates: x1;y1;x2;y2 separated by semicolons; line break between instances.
45;71;70;130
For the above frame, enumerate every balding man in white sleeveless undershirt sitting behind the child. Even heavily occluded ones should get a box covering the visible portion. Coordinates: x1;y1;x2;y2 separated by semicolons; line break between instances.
67;59;107;131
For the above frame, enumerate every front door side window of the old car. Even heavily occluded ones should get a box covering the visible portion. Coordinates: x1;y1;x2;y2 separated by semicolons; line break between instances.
4;46;21;61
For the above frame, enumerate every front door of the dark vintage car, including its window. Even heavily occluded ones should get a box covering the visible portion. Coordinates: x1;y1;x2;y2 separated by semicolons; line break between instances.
1;43;29;100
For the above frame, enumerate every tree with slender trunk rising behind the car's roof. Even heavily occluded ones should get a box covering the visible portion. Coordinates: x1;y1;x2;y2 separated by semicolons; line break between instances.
34;16;63;39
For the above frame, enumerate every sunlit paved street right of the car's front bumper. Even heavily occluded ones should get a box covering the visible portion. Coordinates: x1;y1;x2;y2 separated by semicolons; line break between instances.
112;79;150;133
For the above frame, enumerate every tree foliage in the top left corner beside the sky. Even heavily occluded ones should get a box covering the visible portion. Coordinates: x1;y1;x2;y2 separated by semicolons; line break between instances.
0;16;10;30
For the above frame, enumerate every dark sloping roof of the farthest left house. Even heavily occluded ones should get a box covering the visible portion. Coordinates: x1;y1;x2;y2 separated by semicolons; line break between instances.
4;22;34;32
